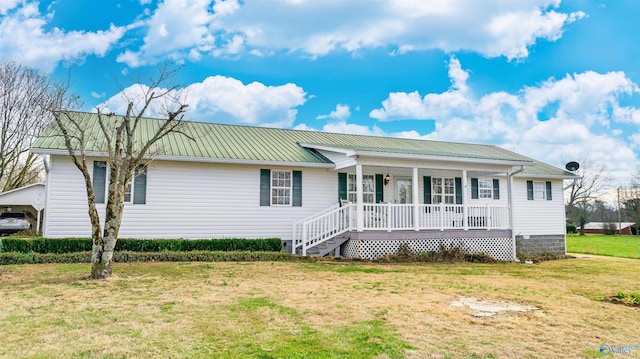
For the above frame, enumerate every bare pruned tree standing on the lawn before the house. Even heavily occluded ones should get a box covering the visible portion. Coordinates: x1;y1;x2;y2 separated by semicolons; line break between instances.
54;64;188;279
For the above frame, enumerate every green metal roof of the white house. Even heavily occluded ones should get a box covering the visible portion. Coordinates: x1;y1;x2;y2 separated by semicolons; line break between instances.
27;112;564;175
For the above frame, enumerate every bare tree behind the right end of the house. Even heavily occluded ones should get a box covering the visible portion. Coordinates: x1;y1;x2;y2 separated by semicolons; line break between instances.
565;158;609;236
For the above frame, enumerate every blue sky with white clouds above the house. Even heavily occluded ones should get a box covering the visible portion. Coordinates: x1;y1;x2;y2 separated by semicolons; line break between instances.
0;0;640;188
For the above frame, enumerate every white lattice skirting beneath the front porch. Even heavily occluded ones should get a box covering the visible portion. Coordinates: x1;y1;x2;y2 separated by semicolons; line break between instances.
341;237;513;261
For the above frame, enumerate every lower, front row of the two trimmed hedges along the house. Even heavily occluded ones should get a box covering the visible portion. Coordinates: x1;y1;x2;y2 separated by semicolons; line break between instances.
0;251;296;265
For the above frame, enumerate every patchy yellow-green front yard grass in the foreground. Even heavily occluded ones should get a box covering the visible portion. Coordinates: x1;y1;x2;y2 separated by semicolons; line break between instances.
0;257;640;358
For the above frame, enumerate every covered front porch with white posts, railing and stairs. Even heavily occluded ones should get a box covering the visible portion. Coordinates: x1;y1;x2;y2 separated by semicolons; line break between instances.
292;159;516;260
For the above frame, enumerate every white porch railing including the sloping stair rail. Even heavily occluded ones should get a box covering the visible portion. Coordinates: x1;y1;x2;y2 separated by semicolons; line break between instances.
292;203;510;255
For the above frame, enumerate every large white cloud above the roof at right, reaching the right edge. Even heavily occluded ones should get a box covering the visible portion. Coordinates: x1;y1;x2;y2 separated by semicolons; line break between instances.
370;58;640;186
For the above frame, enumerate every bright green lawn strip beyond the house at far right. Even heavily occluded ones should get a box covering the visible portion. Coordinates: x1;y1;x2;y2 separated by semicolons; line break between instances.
567;234;640;259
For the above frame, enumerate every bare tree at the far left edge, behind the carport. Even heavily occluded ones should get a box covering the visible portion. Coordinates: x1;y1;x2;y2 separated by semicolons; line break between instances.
0;62;67;192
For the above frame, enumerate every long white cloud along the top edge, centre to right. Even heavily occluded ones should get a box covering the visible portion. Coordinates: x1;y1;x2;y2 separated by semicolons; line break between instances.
118;0;586;67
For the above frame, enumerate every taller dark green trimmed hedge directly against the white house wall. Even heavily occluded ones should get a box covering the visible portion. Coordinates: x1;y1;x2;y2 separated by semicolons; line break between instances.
0;238;282;254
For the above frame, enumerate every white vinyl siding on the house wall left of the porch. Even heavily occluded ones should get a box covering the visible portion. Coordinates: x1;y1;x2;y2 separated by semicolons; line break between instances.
44;156;338;240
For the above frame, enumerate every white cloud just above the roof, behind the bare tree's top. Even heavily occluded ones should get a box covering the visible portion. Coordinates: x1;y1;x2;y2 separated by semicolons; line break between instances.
100;76;306;127
